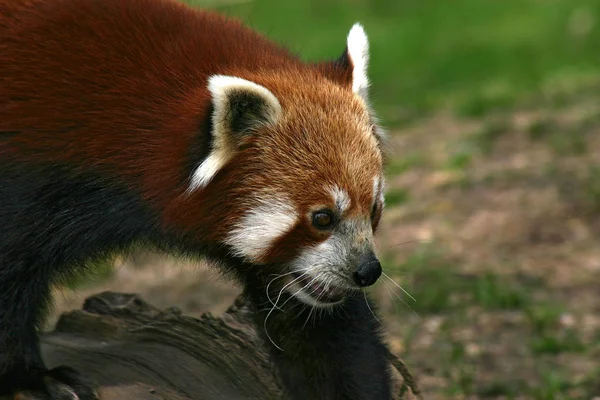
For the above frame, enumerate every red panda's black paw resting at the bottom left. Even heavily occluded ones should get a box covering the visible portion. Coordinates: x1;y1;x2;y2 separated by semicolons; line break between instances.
9;366;99;400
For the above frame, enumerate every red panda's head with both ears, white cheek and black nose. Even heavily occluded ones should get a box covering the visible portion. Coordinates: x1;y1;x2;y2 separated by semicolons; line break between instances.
188;24;384;306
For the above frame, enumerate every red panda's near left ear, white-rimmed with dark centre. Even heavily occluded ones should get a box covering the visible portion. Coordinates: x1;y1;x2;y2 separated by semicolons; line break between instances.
189;75;281;191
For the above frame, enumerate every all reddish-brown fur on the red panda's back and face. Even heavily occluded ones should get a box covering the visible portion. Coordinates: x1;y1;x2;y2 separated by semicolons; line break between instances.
0;0;382;261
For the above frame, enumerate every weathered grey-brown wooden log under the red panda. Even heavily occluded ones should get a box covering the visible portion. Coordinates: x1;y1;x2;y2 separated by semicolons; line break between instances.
35;292;419;400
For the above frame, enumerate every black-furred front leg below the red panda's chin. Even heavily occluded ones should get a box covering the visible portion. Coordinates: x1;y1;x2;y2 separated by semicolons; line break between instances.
246;278;391;400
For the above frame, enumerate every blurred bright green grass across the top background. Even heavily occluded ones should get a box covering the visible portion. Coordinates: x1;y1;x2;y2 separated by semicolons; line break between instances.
188;0;600;125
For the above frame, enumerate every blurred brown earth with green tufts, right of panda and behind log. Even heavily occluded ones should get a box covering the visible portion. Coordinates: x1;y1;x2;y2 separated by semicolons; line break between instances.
50;99;600;399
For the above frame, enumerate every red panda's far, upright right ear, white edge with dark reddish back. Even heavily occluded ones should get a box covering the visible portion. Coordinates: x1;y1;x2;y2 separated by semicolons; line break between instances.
317;23;369;100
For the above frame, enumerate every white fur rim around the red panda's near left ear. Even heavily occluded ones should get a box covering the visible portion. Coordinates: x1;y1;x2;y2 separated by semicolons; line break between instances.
188;75;281;192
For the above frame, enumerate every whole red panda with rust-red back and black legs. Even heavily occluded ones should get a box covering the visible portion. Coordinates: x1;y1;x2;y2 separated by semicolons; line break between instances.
0;0;390;399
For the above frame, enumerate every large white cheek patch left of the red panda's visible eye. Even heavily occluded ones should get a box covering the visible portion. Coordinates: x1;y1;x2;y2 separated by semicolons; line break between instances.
225;196;298;262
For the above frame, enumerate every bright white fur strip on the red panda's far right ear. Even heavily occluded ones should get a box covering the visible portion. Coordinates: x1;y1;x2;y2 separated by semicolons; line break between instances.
346;23;369;99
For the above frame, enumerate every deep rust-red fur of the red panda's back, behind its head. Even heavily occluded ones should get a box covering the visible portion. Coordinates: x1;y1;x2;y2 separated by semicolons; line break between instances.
0;0;298;172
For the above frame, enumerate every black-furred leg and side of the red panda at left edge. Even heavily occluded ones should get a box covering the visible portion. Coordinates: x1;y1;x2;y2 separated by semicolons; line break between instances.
0;164;152;400
